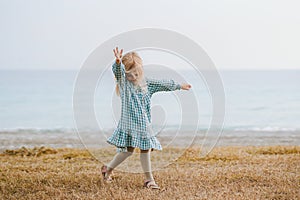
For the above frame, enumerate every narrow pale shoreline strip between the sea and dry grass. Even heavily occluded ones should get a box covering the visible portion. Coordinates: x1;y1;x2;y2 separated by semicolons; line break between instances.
0;131;300;152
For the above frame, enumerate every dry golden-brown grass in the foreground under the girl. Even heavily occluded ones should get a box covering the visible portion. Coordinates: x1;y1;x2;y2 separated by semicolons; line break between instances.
0;146;300;200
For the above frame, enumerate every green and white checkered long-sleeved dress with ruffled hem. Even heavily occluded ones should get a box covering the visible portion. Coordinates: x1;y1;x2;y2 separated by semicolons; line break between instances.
107;63;181;152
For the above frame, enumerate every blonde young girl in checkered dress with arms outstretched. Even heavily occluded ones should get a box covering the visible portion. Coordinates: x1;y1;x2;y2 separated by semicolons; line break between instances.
101;47;191;189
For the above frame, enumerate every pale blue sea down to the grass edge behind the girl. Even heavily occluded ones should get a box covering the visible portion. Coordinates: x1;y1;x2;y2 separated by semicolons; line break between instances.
0;70;300;150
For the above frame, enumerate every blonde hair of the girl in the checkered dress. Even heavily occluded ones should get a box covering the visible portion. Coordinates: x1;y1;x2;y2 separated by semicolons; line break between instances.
116;51;144;95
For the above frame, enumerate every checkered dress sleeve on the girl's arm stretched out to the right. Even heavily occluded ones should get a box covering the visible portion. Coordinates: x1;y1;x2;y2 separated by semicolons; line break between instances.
147;79;181;95
